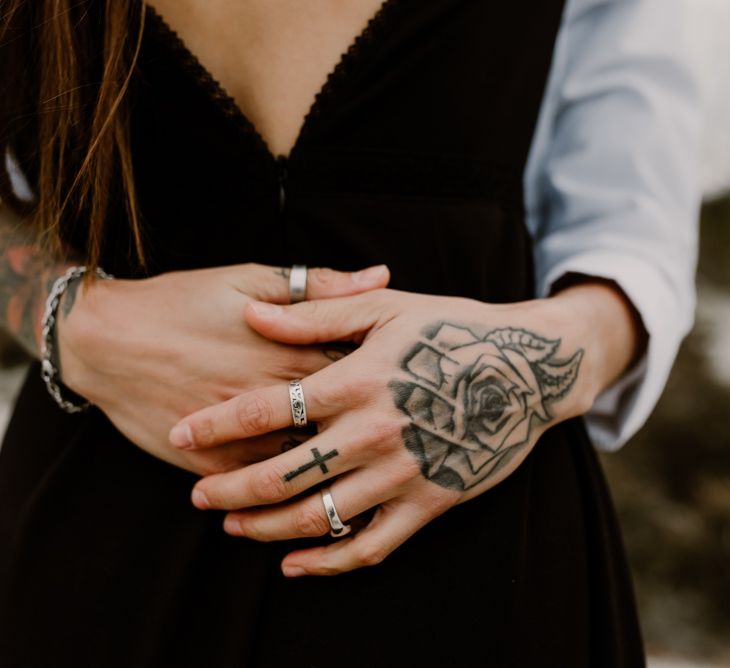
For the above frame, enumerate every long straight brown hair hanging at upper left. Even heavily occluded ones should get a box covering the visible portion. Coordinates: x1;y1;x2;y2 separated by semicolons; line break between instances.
0;0;145;266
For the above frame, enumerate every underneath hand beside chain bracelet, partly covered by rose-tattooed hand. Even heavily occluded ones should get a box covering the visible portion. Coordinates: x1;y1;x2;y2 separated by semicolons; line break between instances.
58;264;388;474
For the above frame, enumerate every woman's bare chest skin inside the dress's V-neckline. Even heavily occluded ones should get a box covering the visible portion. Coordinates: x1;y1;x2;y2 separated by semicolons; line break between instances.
148;0;390;154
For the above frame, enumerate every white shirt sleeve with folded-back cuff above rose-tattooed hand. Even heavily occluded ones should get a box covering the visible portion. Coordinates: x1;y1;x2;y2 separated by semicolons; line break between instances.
525;0;702;450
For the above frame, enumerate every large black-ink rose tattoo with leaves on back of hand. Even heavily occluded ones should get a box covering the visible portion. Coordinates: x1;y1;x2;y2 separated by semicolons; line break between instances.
390;322;583;490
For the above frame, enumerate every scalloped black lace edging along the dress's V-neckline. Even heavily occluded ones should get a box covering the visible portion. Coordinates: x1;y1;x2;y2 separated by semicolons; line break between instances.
147;0;398;163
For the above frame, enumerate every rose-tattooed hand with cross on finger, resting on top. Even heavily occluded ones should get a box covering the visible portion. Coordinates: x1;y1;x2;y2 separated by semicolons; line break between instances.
176;286;632;576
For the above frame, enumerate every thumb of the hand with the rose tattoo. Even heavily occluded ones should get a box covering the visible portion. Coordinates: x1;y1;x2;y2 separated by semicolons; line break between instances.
245;290;388;345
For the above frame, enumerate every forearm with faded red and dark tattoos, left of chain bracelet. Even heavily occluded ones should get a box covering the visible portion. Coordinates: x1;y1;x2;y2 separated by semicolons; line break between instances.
0;203;78;357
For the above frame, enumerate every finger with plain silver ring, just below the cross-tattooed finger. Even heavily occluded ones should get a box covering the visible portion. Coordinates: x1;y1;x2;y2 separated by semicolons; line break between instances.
223;469;400;542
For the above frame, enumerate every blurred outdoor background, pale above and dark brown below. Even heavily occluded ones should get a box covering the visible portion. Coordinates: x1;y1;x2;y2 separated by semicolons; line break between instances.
0;0;730;668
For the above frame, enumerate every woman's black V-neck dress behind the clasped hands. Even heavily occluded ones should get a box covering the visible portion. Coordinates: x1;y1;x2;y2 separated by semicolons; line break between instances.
0;0;643;668
